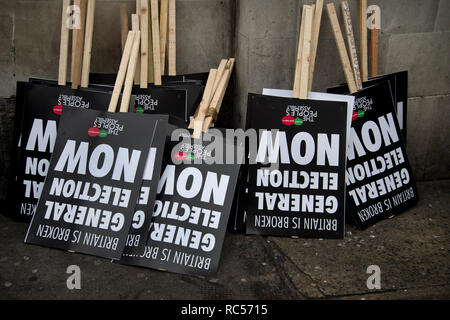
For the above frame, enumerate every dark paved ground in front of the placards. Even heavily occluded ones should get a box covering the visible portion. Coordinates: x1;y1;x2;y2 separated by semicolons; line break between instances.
0;181;450;299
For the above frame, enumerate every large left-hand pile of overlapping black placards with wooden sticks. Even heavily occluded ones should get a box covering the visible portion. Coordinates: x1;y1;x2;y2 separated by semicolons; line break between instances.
16;0;242;275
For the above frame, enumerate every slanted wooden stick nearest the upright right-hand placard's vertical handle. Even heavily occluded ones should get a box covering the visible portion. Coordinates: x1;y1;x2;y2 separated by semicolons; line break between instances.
327;3;358;93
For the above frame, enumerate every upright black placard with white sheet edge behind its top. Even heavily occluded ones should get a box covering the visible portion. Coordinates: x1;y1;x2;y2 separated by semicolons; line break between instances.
246;94;348;238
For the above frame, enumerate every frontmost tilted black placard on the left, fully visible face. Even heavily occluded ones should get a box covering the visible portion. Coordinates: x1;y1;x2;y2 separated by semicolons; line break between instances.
25;107;166;259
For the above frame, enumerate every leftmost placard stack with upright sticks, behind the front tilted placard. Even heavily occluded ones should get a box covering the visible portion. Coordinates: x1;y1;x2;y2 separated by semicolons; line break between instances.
8;0;116;221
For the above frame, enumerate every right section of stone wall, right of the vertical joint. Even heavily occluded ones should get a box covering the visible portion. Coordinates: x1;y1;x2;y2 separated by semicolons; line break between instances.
235;0;450;180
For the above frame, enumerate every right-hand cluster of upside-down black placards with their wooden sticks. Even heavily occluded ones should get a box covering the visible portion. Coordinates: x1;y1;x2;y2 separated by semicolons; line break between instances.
234;1;417;238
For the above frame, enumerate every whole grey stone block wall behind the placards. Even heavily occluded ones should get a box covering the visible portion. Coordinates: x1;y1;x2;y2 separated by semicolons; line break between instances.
0;0;450;197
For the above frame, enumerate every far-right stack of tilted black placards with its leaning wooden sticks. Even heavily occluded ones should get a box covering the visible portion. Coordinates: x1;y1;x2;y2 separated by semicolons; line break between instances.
327;1;418;229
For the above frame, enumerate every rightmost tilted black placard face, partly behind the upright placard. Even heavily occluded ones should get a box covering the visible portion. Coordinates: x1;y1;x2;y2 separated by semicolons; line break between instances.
346;81;418;229
